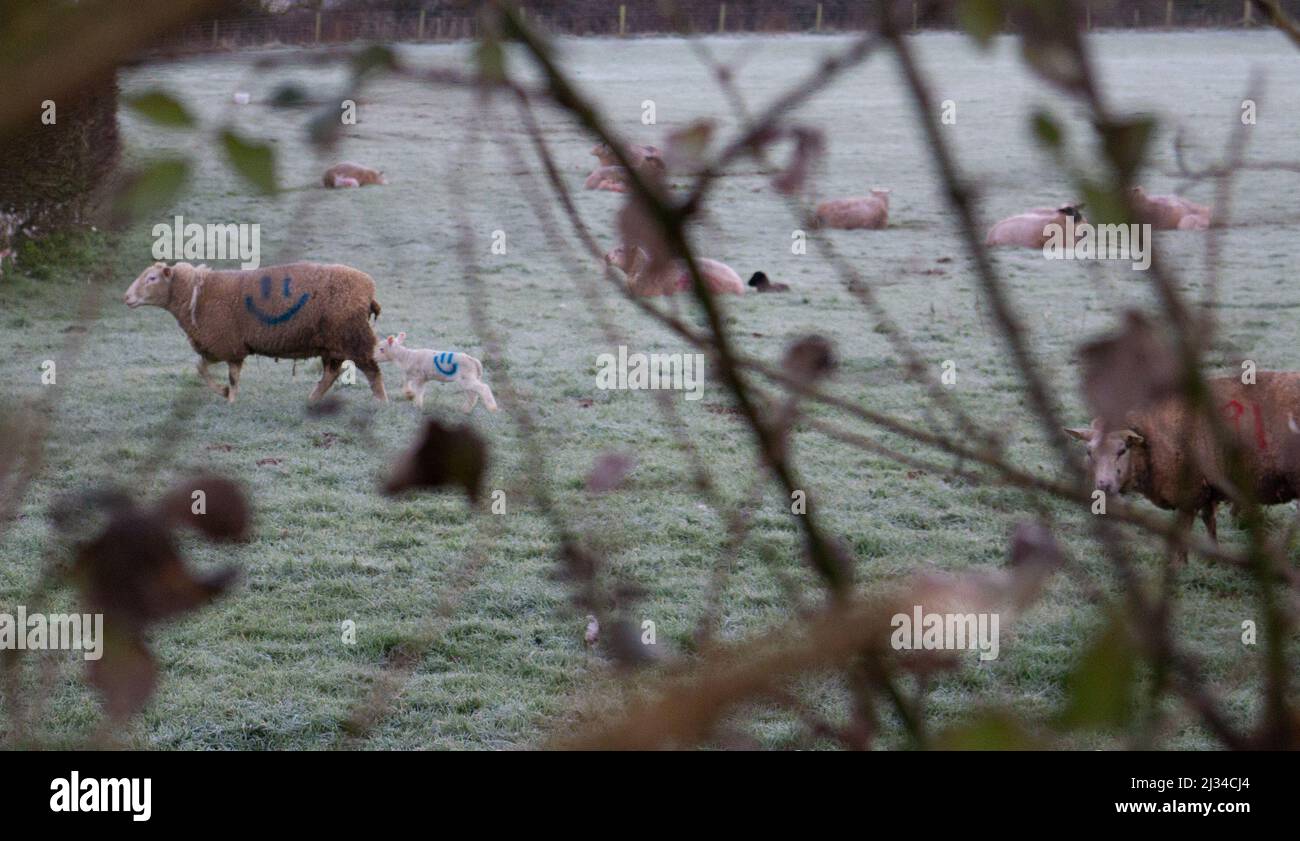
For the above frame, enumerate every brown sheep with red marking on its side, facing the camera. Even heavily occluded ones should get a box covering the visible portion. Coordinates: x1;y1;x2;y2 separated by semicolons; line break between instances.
1066;370;1300;562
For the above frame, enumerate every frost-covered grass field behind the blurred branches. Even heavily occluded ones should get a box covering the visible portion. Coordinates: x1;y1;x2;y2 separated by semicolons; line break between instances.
0;32;1300;749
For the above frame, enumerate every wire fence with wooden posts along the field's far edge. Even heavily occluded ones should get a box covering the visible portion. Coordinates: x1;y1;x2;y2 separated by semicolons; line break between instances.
160;0;1300;51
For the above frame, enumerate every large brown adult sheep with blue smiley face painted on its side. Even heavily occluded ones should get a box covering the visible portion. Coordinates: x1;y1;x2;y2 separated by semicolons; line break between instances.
124;263;387;403
